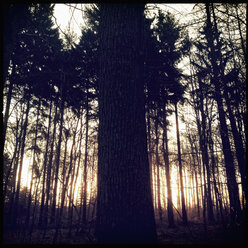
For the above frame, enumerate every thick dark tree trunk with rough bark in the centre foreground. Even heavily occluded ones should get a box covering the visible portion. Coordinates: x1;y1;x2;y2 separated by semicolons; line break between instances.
96;4;157;243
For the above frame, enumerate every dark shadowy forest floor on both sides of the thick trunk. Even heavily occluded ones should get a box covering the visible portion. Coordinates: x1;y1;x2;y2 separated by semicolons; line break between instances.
3;222;248;247
